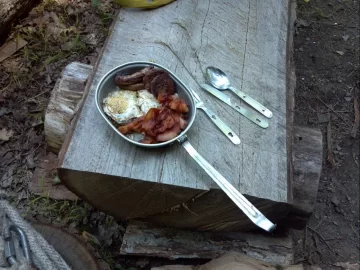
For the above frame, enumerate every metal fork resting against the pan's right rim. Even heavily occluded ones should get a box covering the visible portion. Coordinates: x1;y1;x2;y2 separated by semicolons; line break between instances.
190;89;241;144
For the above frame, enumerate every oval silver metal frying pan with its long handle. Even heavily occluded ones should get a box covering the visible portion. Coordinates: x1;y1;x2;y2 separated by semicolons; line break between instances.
95;62;276;232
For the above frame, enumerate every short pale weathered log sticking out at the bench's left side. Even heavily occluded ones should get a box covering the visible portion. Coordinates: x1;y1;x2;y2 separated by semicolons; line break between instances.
44;62;93;154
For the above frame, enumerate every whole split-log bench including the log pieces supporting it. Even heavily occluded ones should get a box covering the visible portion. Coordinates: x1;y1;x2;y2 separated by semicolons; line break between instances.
28;1;322;265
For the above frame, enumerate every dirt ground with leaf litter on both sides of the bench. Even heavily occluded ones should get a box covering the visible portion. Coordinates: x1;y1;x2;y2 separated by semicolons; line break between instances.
0;0;360;270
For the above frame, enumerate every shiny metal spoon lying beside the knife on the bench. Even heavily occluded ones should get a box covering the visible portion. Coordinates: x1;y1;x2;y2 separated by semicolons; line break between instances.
206;67;273;118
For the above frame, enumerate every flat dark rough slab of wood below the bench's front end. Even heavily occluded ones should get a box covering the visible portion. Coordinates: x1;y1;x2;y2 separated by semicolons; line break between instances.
120;222;293;266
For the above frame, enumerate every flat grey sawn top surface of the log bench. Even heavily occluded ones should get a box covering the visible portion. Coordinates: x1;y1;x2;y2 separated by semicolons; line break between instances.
61;1;288;202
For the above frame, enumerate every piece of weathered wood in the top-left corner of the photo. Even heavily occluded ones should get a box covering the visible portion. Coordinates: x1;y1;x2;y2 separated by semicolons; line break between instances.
0;0;39;39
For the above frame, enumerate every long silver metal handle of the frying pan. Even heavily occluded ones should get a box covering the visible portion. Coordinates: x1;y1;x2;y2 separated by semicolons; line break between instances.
178;135;276;232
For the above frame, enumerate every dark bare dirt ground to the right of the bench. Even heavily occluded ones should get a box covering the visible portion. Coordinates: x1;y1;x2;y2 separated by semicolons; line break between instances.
294;0;360;269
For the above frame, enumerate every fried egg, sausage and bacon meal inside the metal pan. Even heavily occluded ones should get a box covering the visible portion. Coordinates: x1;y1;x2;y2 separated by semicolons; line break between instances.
103;67;189;144
